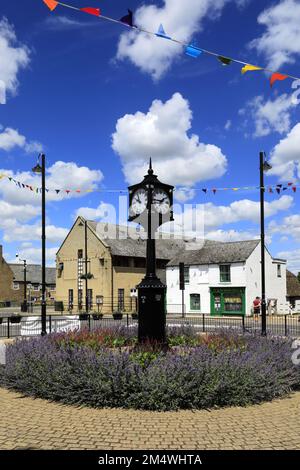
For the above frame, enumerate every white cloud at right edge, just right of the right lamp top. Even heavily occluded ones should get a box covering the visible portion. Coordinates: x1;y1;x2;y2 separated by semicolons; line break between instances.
270;123;300;180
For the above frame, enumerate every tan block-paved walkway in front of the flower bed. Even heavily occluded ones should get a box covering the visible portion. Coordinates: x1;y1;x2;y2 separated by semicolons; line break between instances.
0;389;300;450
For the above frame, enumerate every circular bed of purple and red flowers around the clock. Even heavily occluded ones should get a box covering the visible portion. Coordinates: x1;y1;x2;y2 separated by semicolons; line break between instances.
1;328;300;411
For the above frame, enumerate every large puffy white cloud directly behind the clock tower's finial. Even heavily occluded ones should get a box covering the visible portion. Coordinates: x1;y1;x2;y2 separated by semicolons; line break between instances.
112;93;227;194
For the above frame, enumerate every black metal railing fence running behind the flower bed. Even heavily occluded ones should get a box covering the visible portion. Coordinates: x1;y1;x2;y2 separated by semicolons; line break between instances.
0;314;300;338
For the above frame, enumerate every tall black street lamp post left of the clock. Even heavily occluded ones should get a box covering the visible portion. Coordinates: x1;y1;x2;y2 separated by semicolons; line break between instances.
32;154;47;336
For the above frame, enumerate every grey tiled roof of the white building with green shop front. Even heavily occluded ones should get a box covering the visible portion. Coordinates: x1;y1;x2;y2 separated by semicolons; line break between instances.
168;240;260;266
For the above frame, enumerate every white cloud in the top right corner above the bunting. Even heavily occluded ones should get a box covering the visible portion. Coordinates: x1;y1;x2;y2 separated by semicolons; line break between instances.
250;0;300;70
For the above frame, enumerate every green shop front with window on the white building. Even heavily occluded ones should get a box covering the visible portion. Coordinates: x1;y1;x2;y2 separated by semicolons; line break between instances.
210;287;246;316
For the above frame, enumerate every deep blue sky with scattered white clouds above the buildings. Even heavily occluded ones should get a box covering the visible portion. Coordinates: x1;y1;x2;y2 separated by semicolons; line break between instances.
0;0;300;272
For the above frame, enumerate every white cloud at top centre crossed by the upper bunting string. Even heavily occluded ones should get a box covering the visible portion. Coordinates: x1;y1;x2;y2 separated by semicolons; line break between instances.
117;0;247;80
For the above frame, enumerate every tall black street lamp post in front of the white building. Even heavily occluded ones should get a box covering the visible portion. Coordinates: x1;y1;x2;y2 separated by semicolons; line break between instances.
259;152;272;336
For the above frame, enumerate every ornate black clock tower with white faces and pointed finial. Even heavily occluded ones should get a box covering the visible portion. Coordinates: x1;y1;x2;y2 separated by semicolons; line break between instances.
128;158;174;343
